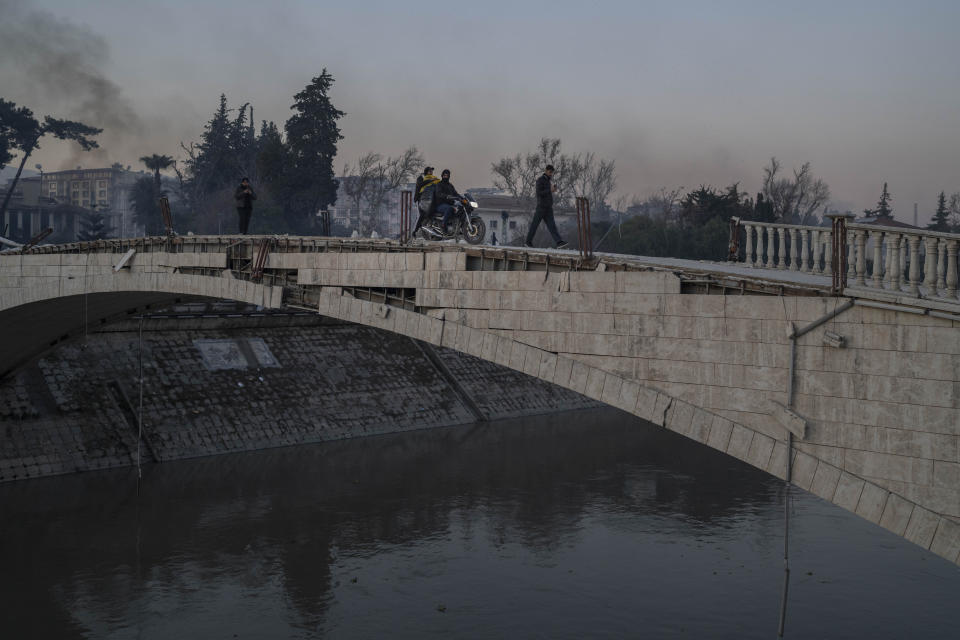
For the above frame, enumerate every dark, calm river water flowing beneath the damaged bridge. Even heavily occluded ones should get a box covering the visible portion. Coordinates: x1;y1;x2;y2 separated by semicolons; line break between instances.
0;409;960;640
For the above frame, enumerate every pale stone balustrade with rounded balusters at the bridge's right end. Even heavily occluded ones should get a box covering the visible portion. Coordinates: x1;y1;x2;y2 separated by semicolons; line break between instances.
738;221;960;303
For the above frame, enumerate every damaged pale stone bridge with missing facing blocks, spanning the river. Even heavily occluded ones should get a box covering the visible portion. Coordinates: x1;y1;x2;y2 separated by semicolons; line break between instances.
0;236;960;563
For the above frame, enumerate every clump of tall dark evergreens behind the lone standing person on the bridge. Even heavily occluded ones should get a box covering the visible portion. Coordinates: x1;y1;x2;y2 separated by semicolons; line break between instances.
154;69;346;234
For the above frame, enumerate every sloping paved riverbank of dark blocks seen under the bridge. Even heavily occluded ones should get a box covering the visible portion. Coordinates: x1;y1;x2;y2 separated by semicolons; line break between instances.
0;305;596;482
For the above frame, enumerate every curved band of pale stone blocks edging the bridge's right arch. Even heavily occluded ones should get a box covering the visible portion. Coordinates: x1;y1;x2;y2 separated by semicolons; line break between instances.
319;290;960;563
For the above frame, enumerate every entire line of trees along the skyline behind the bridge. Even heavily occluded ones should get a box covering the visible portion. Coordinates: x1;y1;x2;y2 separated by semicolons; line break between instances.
0;87;960;250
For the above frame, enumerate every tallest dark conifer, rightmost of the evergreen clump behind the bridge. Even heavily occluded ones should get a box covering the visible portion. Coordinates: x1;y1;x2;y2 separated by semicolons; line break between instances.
284;69;346;230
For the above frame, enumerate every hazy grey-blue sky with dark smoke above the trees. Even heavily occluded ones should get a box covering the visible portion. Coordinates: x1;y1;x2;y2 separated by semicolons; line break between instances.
0;0;960;221
